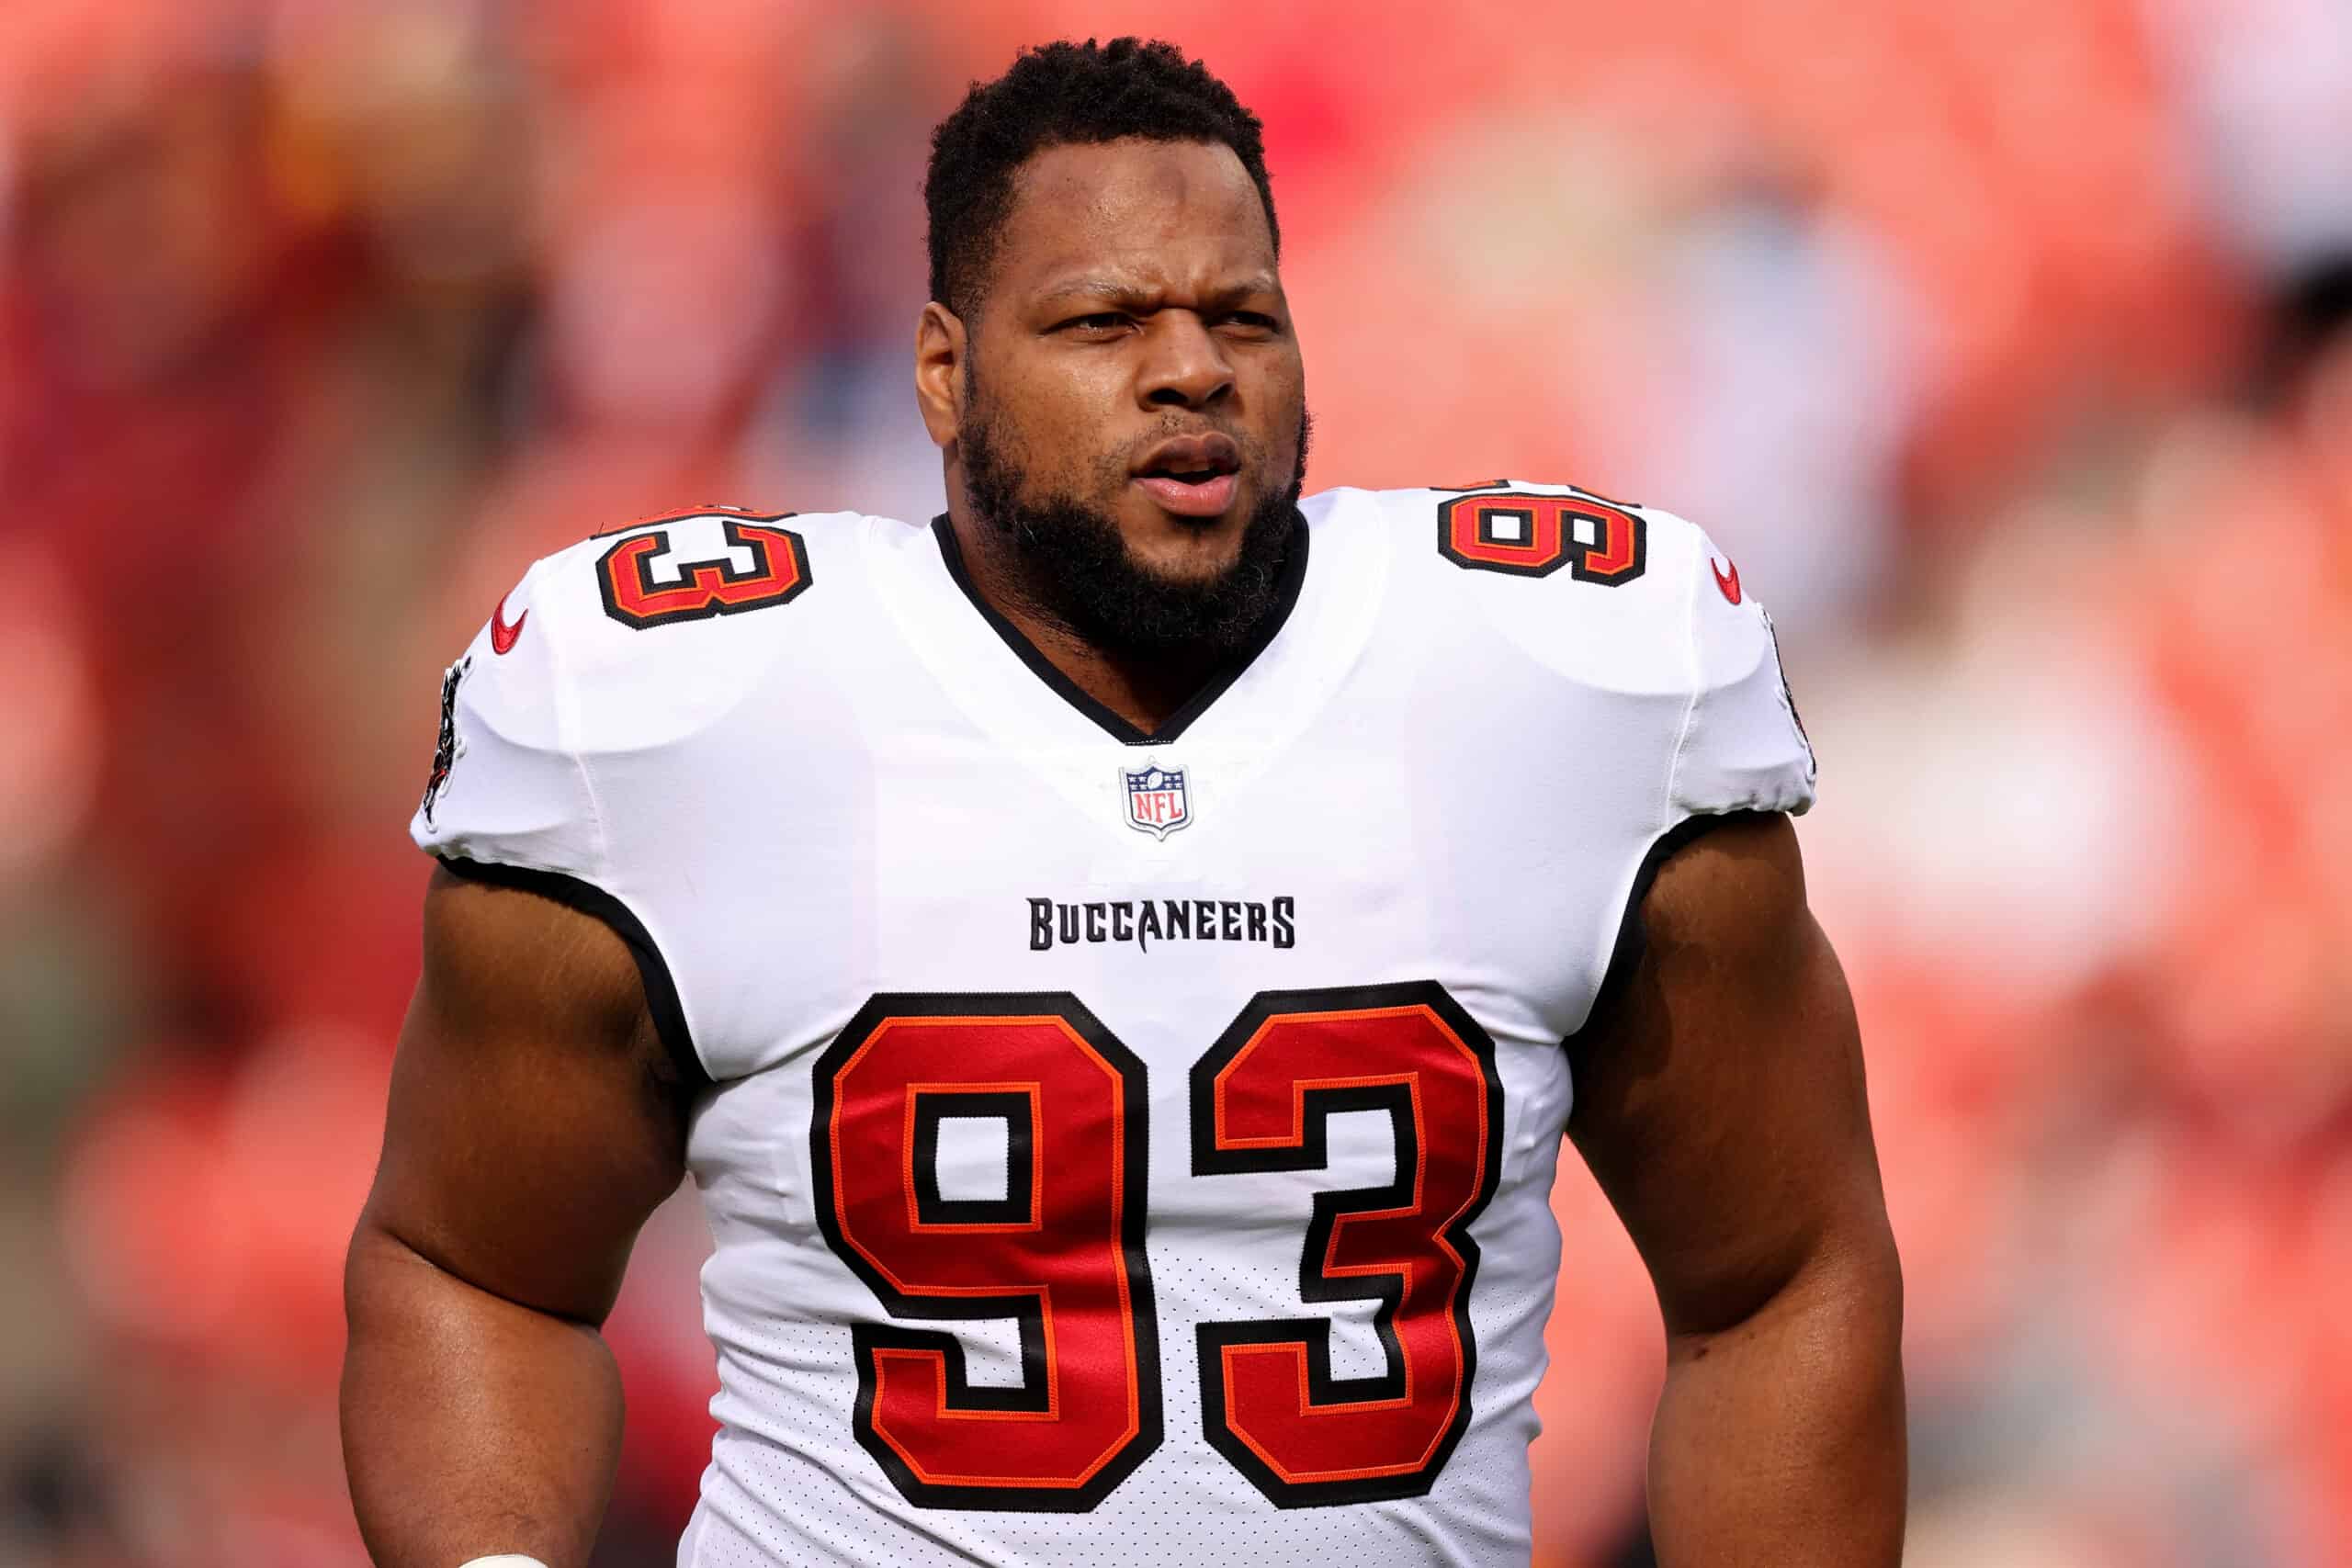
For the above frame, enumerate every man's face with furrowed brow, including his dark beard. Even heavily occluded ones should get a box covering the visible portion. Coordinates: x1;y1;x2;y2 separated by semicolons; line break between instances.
955;141;1306;647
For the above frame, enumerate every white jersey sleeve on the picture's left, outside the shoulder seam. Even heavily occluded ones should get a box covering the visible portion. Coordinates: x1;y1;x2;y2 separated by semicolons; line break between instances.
409;562;606;886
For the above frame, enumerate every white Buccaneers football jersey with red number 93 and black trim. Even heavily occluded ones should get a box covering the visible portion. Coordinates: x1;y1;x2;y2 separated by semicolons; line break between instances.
414;484;1814;1568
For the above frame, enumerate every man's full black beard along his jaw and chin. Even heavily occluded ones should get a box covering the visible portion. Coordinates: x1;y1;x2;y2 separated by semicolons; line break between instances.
957;404;1310;656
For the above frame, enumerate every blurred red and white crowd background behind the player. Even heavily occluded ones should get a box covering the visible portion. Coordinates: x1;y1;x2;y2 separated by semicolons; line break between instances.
0;0;2352;1568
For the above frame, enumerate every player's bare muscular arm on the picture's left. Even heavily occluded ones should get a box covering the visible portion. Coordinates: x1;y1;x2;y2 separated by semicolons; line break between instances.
344;872;687;1568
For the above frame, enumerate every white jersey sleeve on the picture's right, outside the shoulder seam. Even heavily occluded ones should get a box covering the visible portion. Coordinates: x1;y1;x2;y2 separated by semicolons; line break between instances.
1668;534;1815;820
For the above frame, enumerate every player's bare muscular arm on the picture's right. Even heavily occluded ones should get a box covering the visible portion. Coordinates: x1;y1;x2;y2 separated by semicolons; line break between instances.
1569;816;1905;1568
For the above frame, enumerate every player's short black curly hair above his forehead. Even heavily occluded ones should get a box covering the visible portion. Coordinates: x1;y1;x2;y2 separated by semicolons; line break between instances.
922;38;1282;320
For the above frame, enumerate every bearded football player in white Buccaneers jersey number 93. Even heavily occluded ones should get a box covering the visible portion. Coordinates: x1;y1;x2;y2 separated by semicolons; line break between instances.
344;40;1905;1568
